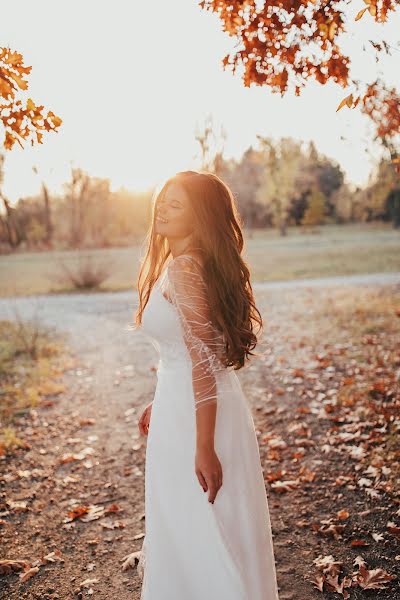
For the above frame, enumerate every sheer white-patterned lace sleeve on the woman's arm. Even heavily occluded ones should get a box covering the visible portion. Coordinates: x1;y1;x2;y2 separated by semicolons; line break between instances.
167;255;225;411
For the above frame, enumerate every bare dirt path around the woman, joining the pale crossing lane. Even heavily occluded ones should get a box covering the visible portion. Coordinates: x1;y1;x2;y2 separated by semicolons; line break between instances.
0;274;400;600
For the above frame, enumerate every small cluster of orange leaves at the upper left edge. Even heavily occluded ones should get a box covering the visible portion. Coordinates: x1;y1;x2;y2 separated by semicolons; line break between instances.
0;48;62;150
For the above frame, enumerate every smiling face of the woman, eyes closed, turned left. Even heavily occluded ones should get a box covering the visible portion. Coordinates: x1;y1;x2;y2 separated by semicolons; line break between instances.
154;183;193;238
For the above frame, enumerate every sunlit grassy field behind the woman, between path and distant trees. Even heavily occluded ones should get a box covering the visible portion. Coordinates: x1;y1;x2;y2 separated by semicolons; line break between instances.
0;224;400;296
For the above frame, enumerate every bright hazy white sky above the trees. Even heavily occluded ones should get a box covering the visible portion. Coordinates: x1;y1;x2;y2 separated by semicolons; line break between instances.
0;0;400;202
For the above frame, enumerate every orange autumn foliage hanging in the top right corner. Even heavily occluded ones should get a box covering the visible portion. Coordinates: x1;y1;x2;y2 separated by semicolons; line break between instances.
199;0;400;168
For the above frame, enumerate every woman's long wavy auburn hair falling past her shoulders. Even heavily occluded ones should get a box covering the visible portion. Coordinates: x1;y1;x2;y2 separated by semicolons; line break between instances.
135;171;263;370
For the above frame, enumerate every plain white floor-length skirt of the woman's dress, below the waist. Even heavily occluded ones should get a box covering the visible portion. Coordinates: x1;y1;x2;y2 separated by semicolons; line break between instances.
138;361;278;600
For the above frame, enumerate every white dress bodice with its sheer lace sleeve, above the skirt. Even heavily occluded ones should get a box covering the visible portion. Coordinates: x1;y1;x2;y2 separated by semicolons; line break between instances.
138;255;233;410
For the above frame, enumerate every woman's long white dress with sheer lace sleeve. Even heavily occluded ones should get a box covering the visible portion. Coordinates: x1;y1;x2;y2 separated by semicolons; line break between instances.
138;255;279;600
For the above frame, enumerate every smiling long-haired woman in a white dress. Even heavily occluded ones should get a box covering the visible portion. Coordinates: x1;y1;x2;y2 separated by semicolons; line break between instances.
135;171;278;600
